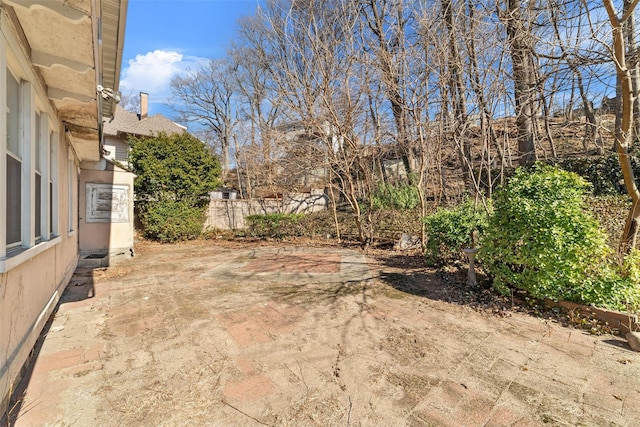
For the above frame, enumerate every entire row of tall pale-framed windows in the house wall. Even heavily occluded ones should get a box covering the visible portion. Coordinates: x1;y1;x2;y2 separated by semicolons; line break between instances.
0;42;62;273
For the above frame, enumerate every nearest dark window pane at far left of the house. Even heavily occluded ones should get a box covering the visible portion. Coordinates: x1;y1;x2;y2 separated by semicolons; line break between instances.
6;70;23;249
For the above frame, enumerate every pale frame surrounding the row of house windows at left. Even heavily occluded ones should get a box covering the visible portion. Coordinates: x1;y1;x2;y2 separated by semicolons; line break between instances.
0;34;62;273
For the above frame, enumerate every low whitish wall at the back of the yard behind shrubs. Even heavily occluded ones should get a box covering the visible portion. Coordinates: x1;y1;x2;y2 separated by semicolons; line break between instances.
204;193;329;230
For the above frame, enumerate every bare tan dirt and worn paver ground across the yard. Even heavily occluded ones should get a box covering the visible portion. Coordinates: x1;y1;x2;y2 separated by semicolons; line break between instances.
10;241;640;426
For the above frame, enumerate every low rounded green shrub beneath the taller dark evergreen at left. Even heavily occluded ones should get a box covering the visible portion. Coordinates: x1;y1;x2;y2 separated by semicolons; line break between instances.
139;200;205;243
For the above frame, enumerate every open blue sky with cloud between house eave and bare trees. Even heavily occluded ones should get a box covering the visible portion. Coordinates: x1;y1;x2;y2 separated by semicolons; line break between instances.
120;0;258;117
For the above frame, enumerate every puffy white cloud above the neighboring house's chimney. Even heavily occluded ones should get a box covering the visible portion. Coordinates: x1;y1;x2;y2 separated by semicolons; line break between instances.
120;50;209;112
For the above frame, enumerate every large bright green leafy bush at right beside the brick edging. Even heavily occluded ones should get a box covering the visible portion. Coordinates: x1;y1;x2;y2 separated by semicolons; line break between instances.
479;165;638;309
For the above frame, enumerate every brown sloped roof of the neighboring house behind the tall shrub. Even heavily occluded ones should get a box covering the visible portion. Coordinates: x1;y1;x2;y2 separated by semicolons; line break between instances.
103;105;187;136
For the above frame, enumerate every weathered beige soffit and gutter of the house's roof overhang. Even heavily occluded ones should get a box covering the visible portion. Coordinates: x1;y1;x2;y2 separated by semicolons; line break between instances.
0;0;127;161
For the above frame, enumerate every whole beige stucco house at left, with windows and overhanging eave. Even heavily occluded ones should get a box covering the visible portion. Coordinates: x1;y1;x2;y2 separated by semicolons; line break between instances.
0;0;127;414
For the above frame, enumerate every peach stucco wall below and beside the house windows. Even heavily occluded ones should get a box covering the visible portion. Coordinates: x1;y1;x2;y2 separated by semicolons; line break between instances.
0;128;78;413
